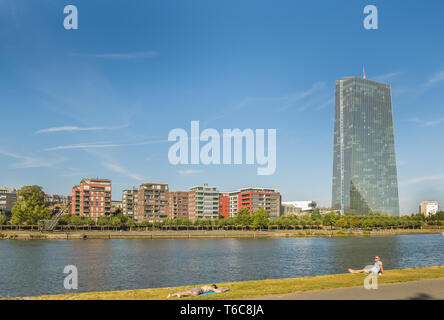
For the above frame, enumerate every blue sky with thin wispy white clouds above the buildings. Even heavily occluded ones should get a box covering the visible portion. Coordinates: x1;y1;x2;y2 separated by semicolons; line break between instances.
0;0;444;213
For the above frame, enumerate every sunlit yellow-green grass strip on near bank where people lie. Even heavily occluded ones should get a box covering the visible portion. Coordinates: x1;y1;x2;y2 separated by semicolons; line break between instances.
26;266;444;300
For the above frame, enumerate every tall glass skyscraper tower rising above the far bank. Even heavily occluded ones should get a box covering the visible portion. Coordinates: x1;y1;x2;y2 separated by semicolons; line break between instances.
332;77;399;216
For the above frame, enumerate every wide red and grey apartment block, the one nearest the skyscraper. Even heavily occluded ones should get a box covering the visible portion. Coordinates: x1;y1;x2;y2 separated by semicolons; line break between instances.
229;187;281;218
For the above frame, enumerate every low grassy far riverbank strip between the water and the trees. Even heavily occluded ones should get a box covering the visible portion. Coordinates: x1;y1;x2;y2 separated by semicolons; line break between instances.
0;229;442;240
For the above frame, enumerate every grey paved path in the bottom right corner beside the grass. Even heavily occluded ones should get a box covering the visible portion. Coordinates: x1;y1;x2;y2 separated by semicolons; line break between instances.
253;279;444;300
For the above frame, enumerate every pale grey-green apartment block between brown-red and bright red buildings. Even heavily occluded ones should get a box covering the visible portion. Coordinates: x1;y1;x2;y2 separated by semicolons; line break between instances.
188;184;219;220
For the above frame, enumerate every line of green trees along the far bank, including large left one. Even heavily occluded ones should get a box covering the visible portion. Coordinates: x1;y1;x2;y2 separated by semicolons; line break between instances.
0;186;444;229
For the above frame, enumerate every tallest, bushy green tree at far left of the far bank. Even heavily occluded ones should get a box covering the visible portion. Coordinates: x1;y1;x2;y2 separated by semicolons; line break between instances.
11;185;50;225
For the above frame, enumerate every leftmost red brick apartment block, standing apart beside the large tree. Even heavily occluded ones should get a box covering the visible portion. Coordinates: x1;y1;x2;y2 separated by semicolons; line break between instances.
71;178;112;220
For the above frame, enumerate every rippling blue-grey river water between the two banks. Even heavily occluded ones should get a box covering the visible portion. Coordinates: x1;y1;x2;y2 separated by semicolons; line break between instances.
0;235;444;297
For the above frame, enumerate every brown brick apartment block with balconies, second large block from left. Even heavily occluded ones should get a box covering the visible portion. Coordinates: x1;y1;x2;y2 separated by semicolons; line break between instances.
135;183;169;222
